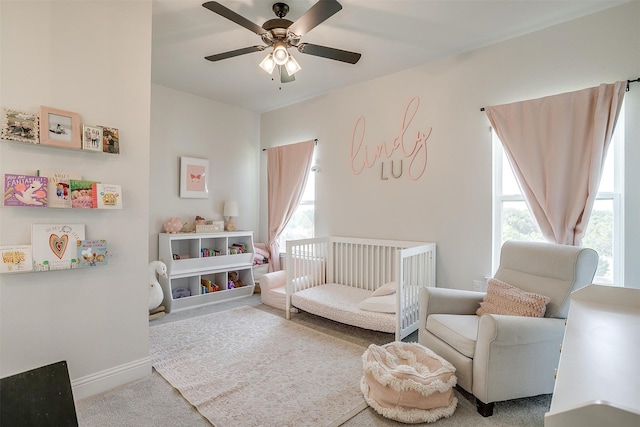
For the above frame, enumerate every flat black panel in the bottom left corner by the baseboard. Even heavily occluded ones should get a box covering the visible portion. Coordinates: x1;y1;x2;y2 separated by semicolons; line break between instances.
0;361;78;427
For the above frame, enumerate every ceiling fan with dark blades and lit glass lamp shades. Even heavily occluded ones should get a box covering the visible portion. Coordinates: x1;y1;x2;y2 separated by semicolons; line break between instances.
202;0;362;83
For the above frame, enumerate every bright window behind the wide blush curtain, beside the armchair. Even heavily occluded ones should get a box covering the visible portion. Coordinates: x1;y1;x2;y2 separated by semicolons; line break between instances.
492;105;625;284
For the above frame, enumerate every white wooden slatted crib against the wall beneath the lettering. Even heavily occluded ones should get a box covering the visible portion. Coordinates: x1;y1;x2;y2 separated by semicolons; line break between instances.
285;236;436;341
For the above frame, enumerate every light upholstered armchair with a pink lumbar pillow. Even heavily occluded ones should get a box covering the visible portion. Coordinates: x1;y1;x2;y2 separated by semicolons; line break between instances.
418;241;598;417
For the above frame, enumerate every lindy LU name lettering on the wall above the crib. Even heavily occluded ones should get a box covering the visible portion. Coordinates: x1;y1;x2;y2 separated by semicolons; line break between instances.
350;96;432;180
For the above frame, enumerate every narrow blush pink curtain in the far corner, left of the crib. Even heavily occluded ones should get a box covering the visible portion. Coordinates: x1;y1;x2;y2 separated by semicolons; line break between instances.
267;141;315;271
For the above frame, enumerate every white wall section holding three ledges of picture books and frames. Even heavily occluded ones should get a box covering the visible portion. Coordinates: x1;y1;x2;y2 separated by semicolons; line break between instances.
0;0;151;398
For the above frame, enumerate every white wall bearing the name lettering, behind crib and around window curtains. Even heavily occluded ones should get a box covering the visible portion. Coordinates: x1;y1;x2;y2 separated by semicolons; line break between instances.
260;2;640;289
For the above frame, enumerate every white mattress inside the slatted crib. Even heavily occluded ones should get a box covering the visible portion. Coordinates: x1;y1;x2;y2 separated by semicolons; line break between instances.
291;283;396;333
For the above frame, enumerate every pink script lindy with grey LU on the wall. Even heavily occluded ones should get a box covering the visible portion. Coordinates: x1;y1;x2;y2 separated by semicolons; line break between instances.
349;96;432;180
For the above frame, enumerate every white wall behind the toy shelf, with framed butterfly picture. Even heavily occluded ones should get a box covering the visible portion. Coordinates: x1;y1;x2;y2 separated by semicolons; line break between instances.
149;84;261;260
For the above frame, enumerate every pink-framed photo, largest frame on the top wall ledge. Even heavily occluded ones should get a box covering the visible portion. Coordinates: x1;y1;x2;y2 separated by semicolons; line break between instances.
40;106;82;150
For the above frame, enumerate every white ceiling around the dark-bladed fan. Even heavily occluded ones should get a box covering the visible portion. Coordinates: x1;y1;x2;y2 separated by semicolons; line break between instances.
151;0;629;112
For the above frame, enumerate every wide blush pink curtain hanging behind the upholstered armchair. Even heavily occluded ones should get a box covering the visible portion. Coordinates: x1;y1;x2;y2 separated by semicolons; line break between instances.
486;81;626;246
